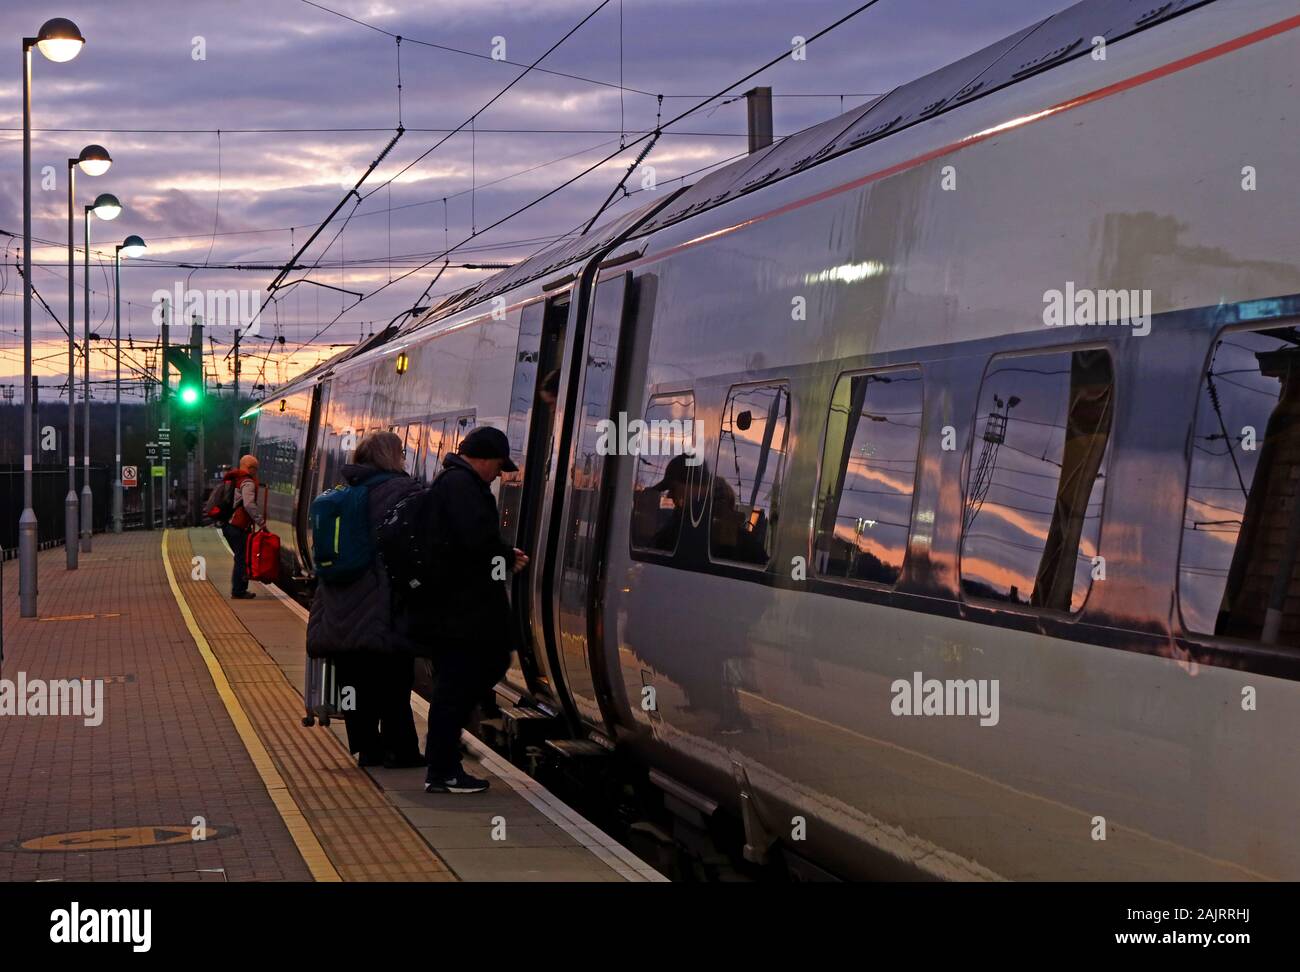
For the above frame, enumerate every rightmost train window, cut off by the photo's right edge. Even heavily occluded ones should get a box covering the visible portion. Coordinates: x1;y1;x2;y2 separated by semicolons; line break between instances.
1178;327;1300;647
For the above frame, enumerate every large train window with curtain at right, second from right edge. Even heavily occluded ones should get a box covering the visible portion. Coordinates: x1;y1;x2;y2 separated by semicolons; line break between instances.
961;350;1114;611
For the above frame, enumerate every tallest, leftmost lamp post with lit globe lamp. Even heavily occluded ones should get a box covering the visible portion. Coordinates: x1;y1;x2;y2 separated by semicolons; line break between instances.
18;17;86;617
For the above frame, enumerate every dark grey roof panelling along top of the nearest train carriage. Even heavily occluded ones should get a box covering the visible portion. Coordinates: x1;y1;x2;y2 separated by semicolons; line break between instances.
638;0;1214;234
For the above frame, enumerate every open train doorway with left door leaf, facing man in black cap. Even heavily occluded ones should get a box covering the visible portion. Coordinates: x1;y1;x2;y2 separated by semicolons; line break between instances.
499;290;569;713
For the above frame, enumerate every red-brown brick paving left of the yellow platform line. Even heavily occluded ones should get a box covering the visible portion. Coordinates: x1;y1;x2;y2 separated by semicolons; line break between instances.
0;531;312;881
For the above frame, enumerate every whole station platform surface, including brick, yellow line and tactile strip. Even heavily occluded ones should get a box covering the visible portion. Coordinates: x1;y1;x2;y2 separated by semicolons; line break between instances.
0;528;663;882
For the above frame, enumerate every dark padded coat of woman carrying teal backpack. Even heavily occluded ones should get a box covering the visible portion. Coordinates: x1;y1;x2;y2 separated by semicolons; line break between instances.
307;465;420;658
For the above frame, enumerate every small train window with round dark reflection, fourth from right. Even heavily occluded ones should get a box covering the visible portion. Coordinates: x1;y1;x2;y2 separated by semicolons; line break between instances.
709;383;790;565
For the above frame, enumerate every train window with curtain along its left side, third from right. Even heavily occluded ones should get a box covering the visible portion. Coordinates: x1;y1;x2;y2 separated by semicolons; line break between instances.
815;368;922;585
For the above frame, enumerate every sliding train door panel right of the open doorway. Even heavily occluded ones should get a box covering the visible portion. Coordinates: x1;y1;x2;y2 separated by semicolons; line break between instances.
547;273;633;738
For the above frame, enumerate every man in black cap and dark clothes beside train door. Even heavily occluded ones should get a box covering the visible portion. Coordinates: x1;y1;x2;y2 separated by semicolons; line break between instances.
424;426;528;793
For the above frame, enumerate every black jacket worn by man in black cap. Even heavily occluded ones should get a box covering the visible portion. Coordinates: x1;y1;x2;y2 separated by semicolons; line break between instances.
402;454;519;656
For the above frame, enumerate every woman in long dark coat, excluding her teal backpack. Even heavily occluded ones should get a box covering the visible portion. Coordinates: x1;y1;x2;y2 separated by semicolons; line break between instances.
307;431;425;767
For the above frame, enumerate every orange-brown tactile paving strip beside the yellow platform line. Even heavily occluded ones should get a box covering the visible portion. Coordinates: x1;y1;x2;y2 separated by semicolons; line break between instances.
168;530;456;881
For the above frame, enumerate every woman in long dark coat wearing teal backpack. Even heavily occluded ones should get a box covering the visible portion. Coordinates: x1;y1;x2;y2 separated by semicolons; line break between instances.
307;431;424;767
